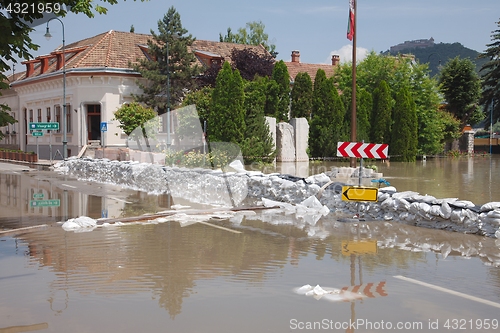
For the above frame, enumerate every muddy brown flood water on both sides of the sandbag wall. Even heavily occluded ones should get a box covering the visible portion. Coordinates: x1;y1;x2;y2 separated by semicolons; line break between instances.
0;156;500;333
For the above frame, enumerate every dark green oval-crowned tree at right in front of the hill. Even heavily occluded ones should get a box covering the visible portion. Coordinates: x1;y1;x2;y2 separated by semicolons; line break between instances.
439;57;484;127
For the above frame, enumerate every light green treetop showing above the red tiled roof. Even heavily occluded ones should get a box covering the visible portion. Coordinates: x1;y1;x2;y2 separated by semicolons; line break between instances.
219;21;278;58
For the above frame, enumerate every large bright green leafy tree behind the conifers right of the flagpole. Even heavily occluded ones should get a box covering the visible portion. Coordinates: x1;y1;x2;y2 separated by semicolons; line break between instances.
334;52;455;155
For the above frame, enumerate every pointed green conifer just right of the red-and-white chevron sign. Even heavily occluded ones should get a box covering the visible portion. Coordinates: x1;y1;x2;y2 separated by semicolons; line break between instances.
389;87;418;162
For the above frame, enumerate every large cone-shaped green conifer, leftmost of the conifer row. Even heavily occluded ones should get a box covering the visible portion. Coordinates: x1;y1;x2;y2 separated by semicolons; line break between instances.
208;62;245;144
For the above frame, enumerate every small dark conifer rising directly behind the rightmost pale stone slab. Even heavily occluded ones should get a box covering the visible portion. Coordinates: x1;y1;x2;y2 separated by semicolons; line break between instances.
290;73;313;120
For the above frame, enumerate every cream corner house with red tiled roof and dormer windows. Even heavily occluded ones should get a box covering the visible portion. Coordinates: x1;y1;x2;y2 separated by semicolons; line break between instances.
0;30;274;159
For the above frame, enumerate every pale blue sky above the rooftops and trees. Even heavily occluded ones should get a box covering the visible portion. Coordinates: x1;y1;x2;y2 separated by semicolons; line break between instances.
3;0;500;70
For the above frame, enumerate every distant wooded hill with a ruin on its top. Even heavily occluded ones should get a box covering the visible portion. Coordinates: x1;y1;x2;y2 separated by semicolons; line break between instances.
383;43;488;76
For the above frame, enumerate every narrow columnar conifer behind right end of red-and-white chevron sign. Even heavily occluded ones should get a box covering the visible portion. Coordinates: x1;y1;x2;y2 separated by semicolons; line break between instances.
370;80;394;143
